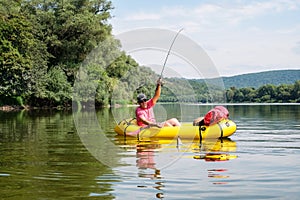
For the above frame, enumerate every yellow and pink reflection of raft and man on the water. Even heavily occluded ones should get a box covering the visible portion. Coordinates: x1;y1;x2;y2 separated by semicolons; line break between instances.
116;136;237;198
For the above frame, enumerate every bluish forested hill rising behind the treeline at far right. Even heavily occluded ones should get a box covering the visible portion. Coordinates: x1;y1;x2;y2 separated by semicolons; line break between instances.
222;70;300;88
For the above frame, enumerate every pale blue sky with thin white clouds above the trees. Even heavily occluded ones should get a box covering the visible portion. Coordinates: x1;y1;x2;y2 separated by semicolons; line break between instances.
109;0;300;78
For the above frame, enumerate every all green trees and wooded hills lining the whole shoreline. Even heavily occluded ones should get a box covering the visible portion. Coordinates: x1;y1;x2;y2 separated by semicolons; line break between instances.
0;0;300;107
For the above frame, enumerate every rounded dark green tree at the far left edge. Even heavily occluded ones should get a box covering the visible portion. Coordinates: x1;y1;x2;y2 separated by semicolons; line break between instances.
0;15;47;100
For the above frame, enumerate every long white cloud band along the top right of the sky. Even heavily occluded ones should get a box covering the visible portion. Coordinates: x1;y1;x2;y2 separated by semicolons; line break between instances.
165;1;299;26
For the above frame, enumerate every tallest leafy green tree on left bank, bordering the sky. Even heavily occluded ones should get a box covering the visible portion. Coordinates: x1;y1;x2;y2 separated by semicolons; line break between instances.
21;0;112;84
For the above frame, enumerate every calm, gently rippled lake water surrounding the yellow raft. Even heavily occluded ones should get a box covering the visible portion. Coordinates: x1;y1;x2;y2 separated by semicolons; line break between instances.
0;104;300;199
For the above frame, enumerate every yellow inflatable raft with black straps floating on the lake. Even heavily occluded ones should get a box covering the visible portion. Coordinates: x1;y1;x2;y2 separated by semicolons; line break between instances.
115;119;236;139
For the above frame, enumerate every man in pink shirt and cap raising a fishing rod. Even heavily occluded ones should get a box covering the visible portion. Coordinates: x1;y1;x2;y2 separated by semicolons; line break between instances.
135;78;180;127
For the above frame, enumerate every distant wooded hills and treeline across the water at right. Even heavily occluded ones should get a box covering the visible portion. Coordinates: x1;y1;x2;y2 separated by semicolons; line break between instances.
156;70;300;103
